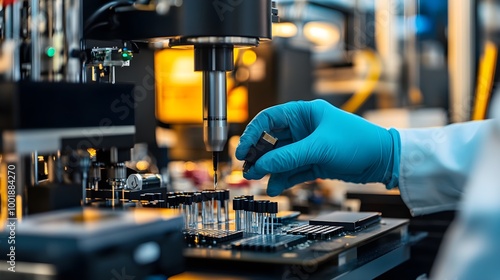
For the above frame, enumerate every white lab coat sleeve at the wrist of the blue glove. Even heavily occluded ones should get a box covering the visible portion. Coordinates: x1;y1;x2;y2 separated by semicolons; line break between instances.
398;120;493;216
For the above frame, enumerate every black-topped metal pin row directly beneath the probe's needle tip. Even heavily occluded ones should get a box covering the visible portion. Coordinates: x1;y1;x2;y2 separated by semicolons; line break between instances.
167;190;229;229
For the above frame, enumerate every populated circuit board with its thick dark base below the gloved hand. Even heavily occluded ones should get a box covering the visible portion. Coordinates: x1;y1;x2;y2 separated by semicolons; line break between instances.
174;194;408;279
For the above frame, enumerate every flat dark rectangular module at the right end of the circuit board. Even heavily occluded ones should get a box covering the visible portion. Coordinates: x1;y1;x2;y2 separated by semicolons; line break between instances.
309;211;382;231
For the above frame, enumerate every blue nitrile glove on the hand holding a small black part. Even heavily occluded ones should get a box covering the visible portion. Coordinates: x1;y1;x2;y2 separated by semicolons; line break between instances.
236;100;400;196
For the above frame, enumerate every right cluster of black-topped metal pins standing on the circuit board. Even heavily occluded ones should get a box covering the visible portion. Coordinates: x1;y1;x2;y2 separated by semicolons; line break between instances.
233;195;278;234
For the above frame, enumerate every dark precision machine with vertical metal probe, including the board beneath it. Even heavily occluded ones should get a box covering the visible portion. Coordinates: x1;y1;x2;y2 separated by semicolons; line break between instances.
0;0;409;280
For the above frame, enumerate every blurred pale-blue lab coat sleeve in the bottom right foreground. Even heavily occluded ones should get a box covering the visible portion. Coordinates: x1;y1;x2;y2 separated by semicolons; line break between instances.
431;97;500;280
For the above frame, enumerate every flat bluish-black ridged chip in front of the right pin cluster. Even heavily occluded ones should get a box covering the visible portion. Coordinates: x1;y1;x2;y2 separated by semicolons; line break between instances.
231;235;307;252
